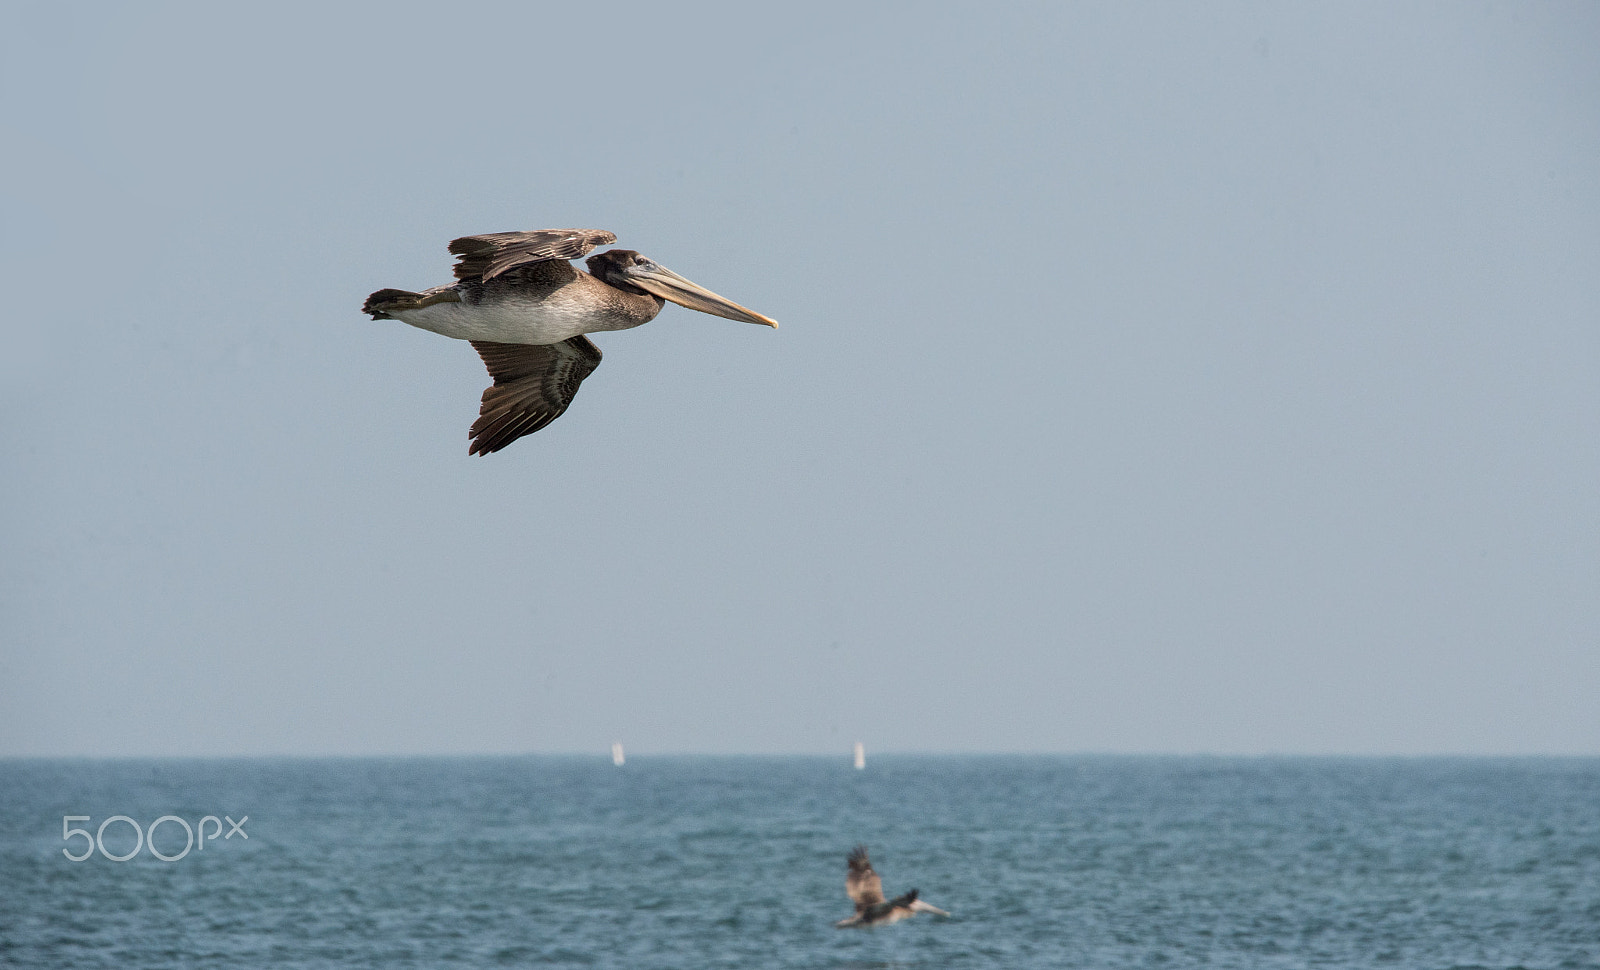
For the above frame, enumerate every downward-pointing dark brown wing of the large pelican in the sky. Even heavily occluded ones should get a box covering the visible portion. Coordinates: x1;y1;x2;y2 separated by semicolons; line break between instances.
467;335;600;455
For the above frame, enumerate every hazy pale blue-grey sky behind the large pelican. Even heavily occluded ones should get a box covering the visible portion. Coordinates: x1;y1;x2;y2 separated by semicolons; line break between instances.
0;3;1600;757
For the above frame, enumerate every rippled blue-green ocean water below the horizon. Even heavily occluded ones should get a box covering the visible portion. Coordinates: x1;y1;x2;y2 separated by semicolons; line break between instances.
0;756;1600;968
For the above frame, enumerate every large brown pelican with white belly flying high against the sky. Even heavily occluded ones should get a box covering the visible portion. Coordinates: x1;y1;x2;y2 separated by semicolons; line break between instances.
362;229;778;455
